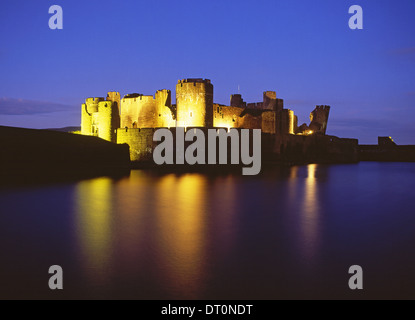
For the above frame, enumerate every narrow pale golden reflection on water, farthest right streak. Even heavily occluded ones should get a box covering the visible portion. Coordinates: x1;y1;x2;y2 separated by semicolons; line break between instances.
301;164;320;261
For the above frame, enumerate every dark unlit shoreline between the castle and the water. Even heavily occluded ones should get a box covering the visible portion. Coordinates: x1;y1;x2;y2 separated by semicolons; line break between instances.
0;126;415;188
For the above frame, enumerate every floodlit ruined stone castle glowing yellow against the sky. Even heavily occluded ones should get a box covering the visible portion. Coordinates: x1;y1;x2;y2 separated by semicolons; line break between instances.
81;78;330;161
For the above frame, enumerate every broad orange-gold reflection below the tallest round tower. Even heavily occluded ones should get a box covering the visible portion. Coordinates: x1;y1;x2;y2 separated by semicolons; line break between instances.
156;174;207;298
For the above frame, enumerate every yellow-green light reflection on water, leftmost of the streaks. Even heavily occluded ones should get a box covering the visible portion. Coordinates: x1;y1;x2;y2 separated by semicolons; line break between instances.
75;177;112;285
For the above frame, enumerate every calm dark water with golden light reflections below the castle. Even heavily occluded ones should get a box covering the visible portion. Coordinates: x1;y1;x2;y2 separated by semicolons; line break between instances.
0;162;415;299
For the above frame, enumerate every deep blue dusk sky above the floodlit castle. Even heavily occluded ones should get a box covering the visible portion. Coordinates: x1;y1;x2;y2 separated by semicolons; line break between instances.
0;0;415;144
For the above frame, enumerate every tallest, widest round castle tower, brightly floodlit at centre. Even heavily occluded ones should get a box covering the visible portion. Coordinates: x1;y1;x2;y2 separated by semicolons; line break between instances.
176;79;213;128
